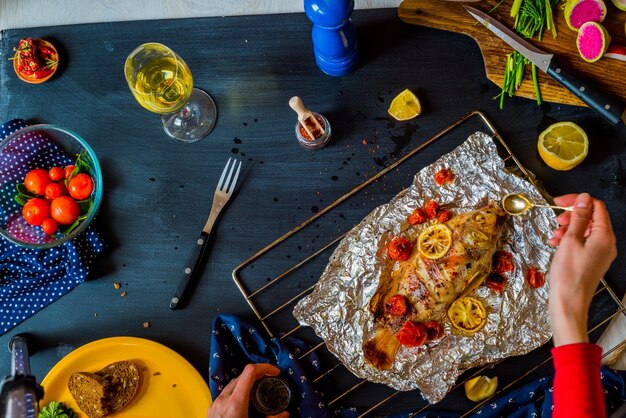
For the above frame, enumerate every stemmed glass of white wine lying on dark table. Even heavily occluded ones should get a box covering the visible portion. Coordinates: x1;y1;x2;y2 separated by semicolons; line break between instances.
124;42;217;142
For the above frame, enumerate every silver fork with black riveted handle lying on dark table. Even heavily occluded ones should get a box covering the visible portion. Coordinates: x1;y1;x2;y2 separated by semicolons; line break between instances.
170;158;241;309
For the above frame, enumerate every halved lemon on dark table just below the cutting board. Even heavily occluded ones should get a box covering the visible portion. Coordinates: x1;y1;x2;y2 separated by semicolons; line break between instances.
537;122;589;171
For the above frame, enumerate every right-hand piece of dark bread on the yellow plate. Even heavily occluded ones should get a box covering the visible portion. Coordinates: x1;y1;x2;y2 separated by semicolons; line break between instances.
96;360;140;413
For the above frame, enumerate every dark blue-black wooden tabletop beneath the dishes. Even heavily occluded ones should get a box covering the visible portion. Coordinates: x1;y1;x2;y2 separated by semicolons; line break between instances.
0;9;626;416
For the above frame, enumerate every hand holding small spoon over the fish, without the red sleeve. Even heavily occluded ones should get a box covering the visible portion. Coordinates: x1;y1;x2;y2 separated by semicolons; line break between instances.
548;193;617;347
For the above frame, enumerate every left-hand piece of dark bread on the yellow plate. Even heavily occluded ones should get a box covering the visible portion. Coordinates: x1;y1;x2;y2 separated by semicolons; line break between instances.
68;372;112;418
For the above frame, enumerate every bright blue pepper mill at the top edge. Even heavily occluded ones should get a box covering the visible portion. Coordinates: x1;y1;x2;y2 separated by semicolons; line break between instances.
304;0;357;76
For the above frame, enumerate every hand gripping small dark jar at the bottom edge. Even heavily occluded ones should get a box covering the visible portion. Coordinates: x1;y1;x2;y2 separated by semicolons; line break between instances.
207;364;289;418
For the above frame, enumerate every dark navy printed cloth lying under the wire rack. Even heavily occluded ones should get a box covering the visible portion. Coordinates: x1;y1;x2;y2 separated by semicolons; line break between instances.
209;315;626;418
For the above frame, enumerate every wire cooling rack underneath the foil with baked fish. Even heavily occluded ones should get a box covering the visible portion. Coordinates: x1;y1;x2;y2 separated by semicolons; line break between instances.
232;111;626;417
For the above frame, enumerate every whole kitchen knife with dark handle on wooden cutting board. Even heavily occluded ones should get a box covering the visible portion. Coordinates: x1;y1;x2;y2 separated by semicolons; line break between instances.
463;6;626;125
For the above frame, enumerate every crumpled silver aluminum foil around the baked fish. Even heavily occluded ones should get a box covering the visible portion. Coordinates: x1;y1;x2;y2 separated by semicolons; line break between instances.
294;132;556;403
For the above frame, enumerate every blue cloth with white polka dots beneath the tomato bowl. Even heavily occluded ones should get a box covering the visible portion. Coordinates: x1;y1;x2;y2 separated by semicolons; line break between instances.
0;119;104;334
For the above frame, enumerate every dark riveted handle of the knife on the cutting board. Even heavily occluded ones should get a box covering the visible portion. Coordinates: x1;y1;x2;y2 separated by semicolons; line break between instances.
546;57;626;125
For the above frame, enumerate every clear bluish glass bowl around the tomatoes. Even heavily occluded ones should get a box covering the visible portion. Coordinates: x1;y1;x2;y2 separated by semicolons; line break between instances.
0;125;102;249
